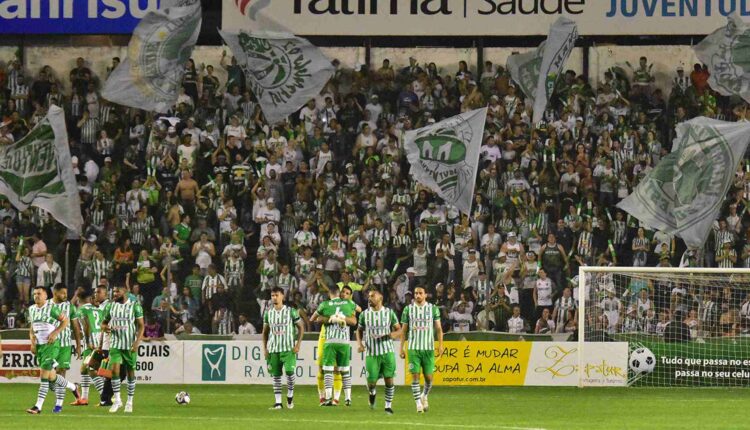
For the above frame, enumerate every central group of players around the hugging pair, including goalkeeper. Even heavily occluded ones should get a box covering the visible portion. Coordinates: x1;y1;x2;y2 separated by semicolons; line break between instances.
263;286;443;414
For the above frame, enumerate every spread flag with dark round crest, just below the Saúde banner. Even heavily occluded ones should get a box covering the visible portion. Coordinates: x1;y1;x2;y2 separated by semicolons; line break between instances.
219;31;334;125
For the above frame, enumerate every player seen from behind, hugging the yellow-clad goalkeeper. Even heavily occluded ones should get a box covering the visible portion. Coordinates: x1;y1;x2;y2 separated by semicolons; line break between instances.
313;287;357;406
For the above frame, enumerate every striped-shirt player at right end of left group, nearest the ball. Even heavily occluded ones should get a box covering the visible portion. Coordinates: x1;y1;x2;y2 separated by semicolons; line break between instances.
102;285;144;413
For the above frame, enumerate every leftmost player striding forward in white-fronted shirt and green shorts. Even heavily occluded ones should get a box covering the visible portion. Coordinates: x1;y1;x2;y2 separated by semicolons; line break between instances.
26;286;80;415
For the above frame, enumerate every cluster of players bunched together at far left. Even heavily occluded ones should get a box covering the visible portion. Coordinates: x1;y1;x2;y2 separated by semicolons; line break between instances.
26;284;144;415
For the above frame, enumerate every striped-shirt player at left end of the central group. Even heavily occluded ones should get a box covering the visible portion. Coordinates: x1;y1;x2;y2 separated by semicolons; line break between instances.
263;287;305;409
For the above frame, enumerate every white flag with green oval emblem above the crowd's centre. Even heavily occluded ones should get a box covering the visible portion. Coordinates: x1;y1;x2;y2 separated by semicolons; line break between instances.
404;108;487;214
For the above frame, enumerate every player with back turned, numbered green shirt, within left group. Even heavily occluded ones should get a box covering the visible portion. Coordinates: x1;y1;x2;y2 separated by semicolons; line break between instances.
71;288;107;406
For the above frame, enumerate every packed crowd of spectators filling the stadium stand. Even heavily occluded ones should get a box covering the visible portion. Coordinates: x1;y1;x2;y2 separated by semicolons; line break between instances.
0;49;750;340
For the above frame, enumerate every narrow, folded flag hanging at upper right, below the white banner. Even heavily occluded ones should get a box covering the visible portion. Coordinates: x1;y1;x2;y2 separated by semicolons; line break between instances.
506;17;578;124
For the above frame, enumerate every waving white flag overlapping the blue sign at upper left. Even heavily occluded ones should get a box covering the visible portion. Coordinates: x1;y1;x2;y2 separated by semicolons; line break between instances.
102;0;201;113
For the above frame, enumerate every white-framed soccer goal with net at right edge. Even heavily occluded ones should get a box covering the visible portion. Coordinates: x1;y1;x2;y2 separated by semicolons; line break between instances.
574;267;750;387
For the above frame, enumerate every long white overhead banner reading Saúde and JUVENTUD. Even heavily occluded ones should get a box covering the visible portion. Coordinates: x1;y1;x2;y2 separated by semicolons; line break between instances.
222;0;750;36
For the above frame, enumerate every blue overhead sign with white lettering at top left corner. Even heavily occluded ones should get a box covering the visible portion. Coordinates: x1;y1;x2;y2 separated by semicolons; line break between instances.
0;0;164;34
